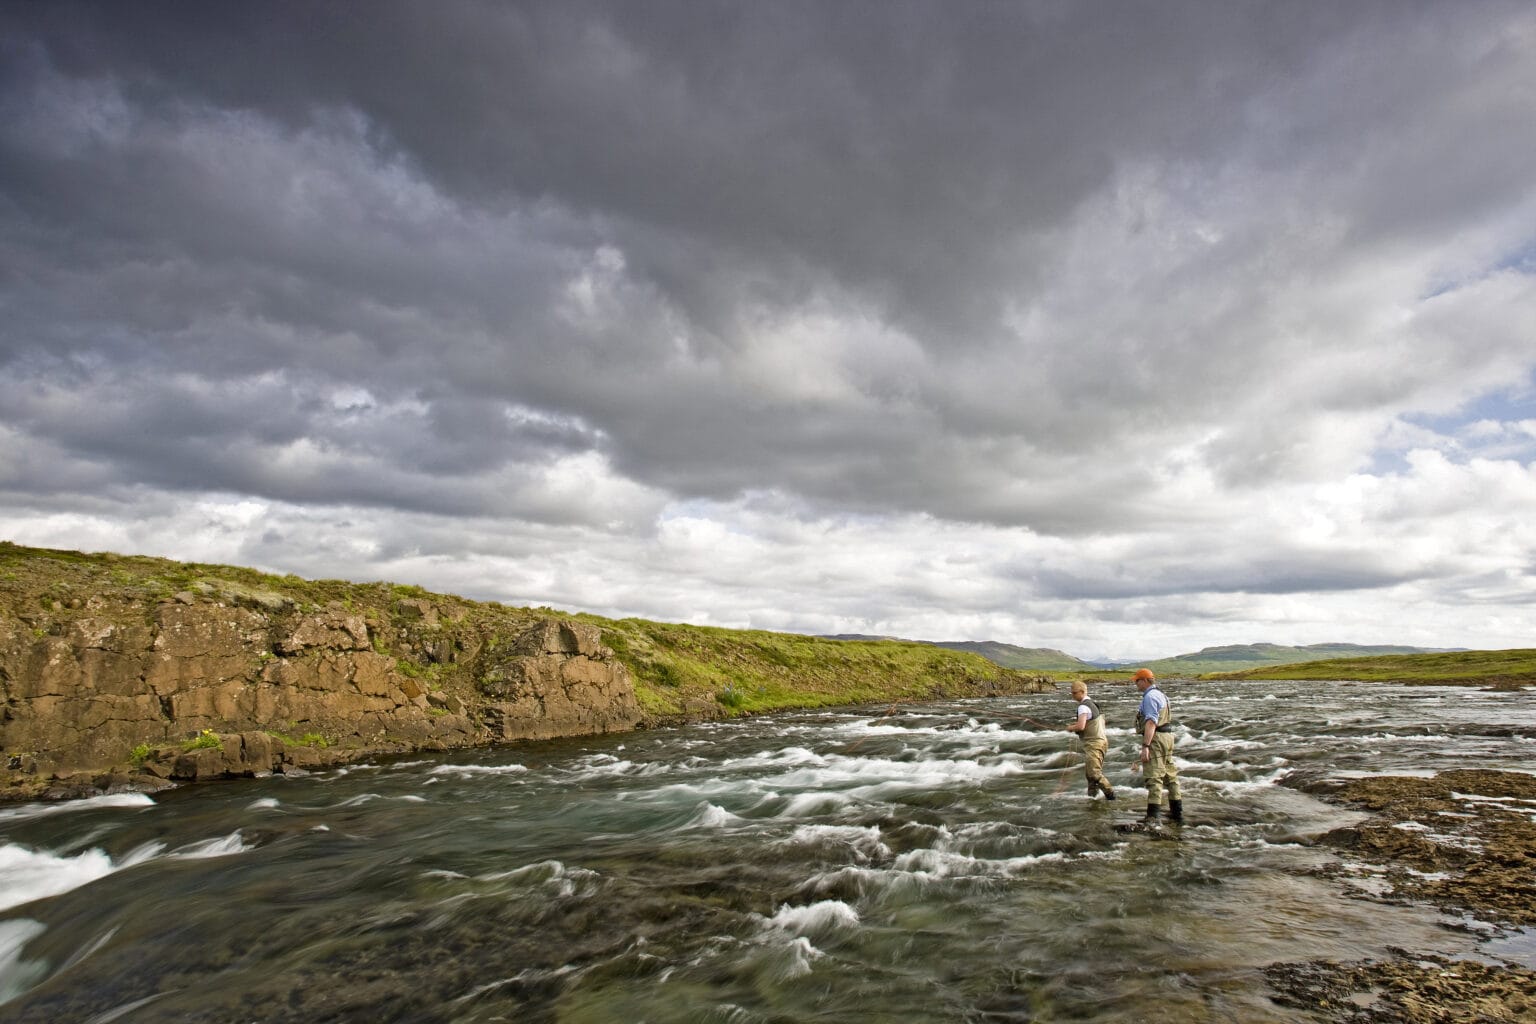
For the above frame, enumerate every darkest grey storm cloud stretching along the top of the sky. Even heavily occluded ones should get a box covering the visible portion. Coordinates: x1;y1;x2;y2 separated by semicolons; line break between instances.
14;3;1407;345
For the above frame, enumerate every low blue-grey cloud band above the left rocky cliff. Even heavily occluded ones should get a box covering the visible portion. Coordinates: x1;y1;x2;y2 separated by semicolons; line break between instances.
0;360;614;520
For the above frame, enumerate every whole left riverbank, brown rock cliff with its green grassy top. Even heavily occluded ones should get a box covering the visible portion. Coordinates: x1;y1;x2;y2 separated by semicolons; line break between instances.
0;542;1051;800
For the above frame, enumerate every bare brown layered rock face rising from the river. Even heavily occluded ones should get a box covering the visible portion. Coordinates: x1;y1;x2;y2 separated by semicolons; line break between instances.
0;594;641;795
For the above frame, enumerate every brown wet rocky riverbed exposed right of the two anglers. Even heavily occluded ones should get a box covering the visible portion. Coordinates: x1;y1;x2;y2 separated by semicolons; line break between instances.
1266;769;1536;1024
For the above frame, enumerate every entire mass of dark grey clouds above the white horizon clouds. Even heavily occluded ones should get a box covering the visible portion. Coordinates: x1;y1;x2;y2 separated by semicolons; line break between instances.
0;2;1536;564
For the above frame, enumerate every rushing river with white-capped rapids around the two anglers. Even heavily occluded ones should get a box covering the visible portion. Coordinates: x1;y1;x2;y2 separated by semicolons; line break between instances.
0;682;1536;1024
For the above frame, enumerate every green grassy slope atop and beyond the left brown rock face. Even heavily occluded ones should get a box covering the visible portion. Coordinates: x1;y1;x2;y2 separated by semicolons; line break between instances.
0;542;1037;723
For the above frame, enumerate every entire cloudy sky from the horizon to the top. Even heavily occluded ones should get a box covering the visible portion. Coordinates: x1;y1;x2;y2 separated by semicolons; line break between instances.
0;0;1536;657
